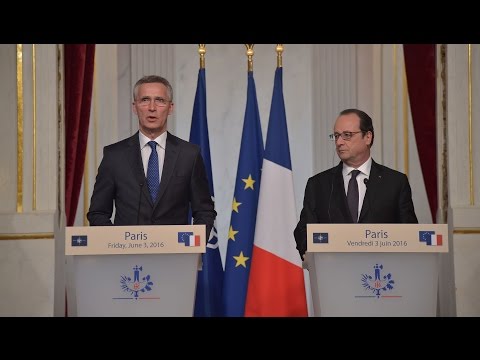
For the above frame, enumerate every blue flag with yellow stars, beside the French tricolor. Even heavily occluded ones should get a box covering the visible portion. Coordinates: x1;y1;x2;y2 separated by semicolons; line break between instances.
223;71;263;316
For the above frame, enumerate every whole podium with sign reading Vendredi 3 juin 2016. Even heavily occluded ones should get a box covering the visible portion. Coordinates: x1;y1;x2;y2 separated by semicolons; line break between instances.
306;224;448;317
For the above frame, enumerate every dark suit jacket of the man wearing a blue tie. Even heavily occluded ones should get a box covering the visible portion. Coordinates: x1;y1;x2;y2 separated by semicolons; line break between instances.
87;131;217;239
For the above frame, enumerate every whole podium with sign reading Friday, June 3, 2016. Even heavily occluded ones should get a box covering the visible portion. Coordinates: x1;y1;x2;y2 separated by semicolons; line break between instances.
65;225;206;317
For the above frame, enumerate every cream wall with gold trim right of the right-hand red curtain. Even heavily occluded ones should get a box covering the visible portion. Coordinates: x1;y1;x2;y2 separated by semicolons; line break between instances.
446;44;480;316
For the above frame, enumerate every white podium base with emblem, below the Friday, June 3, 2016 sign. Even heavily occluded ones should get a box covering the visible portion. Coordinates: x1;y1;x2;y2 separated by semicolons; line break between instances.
67;253;201;317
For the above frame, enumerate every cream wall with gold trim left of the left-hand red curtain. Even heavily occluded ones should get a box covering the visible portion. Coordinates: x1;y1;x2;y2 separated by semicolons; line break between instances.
0;44;58;316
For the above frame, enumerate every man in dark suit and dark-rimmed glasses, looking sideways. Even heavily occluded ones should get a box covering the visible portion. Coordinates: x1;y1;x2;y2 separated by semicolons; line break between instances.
294;109;418;260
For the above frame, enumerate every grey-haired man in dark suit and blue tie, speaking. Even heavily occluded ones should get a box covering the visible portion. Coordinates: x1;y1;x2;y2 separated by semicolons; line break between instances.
87;75;217;239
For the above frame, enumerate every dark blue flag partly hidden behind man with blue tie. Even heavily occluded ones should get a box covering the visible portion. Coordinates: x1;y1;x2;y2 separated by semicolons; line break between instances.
190;68;223;316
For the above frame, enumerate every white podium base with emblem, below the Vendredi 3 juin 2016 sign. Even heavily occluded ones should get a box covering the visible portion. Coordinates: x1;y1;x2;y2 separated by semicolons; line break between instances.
308;253;438;316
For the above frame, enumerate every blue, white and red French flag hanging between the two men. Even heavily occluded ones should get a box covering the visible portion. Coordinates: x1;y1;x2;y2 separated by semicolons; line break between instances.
245;67;308;317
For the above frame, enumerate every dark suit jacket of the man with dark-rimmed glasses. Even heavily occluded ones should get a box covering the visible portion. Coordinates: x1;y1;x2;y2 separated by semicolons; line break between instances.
294;160;418;255
